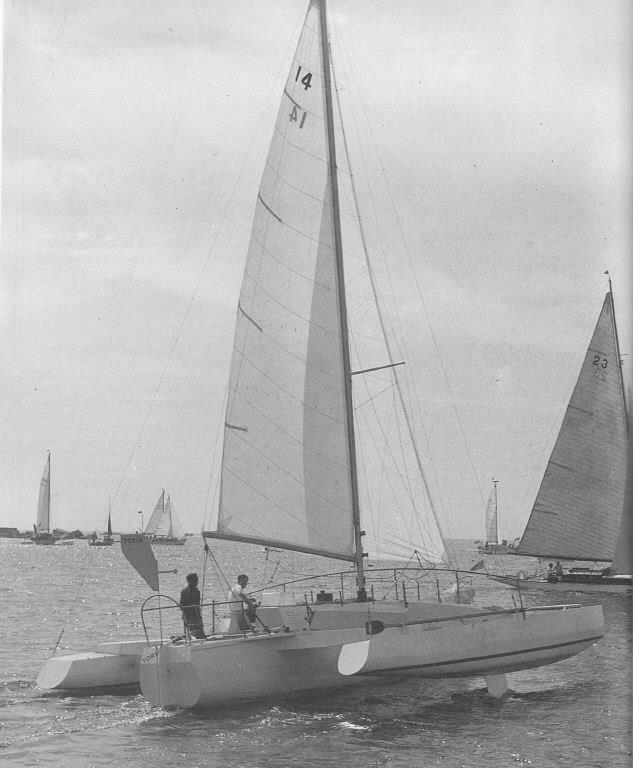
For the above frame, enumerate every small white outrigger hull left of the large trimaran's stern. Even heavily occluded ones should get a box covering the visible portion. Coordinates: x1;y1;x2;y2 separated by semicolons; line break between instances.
37;640;156;690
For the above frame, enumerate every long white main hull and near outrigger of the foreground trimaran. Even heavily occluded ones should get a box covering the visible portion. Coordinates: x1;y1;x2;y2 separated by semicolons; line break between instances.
141;604;604;707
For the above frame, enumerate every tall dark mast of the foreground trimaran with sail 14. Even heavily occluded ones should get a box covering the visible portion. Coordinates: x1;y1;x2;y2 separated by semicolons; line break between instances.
319;0;367;600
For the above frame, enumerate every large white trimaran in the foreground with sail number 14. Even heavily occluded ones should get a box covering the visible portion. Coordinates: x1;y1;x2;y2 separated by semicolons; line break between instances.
140;0;604;708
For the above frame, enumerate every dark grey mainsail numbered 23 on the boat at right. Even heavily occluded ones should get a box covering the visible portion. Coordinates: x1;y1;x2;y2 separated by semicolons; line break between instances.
519;292;627;561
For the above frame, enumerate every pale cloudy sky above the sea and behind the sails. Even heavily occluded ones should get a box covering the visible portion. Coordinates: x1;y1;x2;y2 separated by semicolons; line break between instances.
0;0;633;539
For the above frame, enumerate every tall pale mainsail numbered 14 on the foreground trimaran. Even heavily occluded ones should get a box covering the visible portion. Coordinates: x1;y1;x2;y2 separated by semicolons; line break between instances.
205;0;444;563
